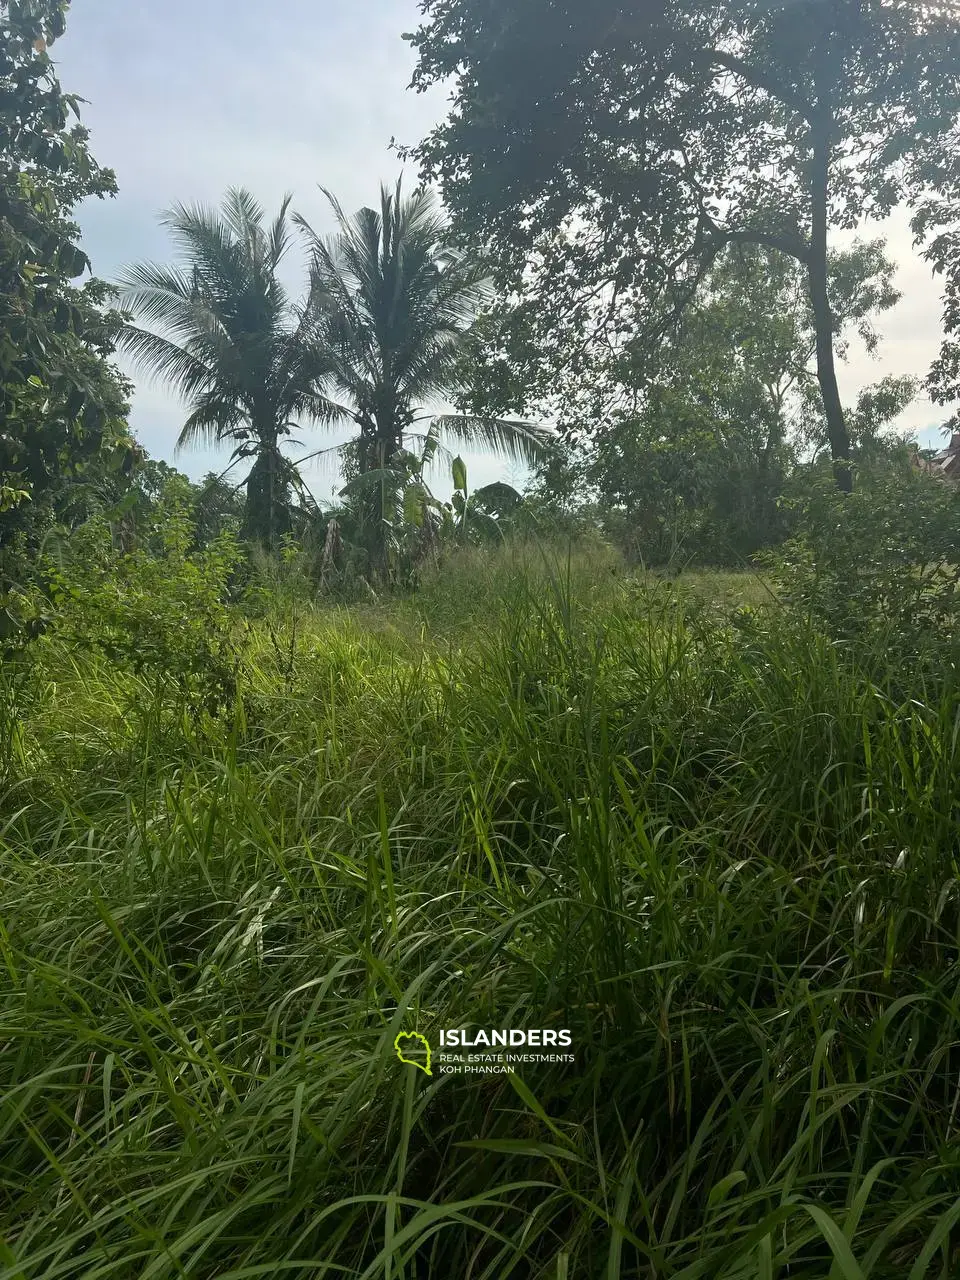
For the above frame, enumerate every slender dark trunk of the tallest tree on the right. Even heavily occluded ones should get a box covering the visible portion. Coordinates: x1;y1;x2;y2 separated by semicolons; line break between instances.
806;122;854;493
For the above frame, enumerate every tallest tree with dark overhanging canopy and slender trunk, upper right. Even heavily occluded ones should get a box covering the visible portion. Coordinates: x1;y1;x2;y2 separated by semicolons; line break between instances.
410;0;960;489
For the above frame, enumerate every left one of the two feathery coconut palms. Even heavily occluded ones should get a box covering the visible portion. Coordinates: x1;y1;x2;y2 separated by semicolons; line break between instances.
119;188;330;547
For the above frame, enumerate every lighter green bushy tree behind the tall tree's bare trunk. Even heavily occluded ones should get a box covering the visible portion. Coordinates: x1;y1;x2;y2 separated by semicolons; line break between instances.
535;241;914;564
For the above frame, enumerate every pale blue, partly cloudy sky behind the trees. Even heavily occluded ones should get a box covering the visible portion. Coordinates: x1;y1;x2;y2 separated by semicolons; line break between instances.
50;0;947;499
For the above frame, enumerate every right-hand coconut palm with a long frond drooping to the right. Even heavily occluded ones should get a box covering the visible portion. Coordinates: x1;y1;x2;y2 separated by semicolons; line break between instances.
294;182;547;571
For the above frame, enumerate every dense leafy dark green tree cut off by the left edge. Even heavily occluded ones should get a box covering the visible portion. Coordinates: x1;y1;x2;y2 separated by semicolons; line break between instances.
0;0;133;568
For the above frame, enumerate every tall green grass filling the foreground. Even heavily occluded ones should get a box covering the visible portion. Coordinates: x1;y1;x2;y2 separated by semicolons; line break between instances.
0;556;960;1280
